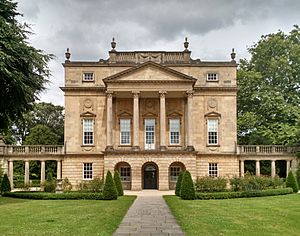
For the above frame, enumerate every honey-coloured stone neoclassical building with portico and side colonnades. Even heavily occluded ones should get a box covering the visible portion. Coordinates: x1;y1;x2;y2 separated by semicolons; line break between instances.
0;40;296;190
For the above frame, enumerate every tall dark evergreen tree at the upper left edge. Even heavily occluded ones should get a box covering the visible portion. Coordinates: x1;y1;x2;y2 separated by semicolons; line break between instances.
0;0;53;132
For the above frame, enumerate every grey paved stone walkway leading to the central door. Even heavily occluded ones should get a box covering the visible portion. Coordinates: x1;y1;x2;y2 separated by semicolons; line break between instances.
114;190;184;236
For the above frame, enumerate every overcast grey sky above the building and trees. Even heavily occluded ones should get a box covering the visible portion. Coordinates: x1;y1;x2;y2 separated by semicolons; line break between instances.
18;0;300;105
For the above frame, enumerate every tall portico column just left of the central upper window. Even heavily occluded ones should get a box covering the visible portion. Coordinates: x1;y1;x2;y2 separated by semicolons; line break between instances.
132;91;140;151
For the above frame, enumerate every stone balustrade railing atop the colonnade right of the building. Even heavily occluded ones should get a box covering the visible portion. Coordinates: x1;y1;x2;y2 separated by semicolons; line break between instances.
237;145;298;155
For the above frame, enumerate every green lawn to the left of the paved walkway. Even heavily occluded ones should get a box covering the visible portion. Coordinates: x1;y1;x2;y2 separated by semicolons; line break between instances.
0;196;135;236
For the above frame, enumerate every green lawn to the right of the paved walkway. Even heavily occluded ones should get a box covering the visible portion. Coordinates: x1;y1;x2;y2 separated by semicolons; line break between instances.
164;194;300;236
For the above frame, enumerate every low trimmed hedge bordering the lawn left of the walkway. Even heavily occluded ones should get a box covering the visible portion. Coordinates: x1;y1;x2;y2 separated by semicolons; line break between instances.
3;192;103;200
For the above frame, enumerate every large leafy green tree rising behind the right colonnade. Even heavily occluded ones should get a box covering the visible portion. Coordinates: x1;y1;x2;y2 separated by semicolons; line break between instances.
237;26;300;144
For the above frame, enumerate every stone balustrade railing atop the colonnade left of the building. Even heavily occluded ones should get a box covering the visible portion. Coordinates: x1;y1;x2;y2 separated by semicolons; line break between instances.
0;145;64;155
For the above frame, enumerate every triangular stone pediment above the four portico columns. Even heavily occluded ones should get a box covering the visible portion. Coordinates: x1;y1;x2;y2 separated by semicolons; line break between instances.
103;61;196;84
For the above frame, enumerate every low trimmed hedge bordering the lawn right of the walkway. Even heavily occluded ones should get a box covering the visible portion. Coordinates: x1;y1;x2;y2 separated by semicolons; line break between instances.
196;188;293;200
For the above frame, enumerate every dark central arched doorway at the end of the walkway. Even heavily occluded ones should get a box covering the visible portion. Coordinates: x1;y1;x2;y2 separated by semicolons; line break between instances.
142;162;158;189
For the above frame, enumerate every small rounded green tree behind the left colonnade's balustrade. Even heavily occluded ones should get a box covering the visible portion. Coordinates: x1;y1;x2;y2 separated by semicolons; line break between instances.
24;125;58;145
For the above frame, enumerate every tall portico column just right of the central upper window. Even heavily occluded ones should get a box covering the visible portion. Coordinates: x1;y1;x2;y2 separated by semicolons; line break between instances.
159;91;167;150
